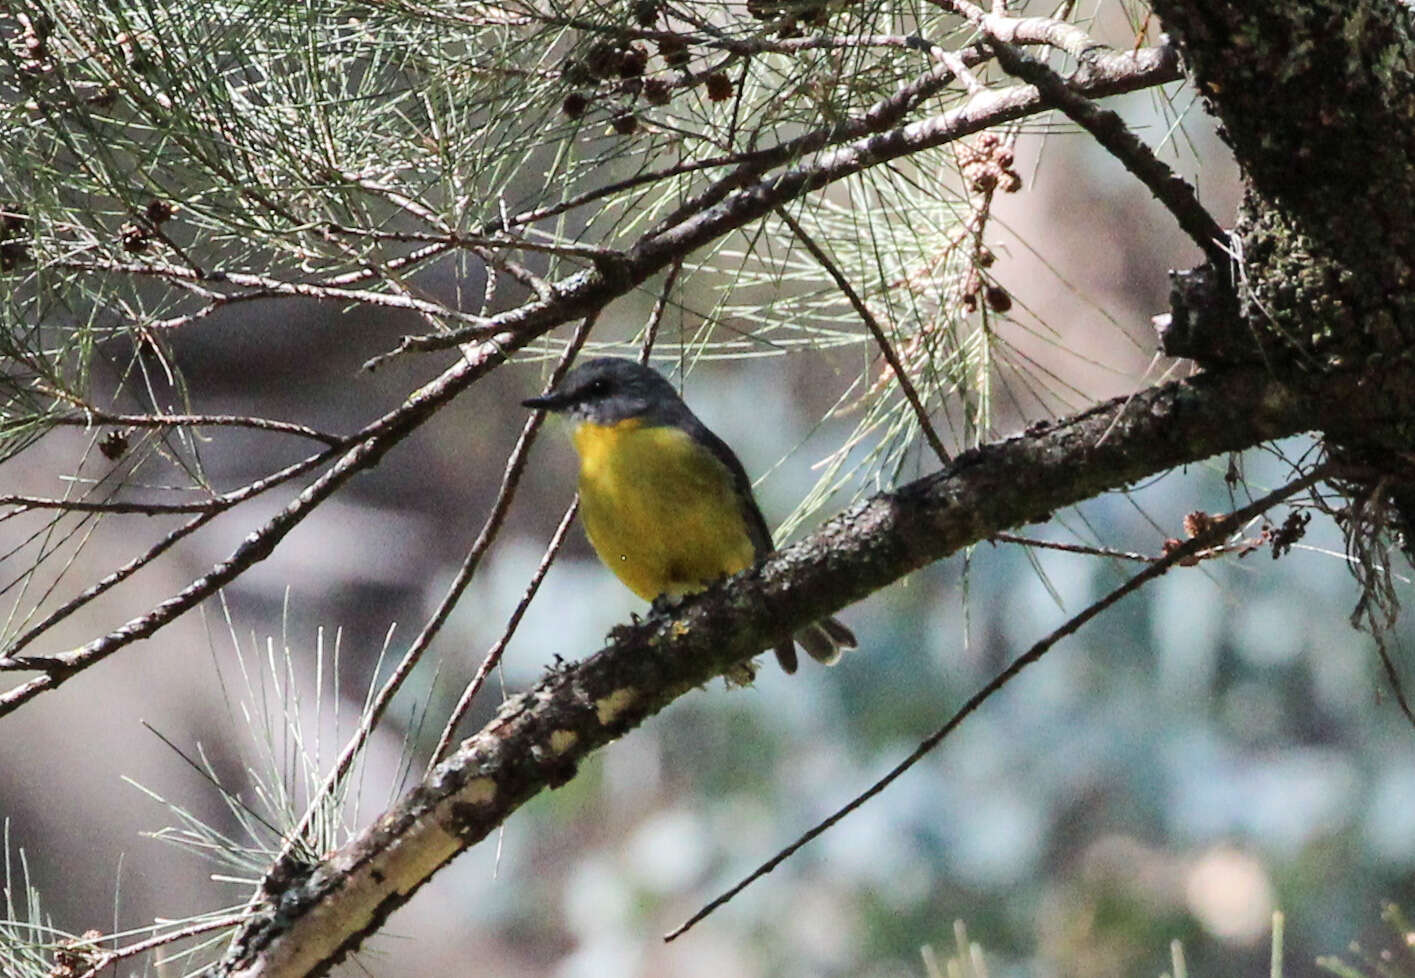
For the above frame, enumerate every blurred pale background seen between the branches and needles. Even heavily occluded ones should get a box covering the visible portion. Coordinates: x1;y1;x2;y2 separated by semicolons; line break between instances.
0;7;1415;978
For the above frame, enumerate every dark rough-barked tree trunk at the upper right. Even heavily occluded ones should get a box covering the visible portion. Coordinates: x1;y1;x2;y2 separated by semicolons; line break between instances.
1153;0;1415;534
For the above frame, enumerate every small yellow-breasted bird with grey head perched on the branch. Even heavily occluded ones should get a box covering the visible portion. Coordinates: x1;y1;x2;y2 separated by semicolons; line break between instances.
522;357;855;672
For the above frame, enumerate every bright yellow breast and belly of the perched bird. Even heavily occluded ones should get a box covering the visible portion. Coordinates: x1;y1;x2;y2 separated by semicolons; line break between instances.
573;419;757;600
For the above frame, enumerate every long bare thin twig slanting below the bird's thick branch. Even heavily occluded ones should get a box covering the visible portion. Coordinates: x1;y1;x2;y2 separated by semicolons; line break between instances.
664;463;1334;941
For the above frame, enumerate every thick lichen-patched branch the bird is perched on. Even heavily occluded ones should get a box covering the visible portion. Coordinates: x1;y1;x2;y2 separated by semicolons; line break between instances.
212;353;1415;978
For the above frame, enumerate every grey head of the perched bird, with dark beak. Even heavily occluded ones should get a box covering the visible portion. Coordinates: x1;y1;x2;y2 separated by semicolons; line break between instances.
521;357;688;425
